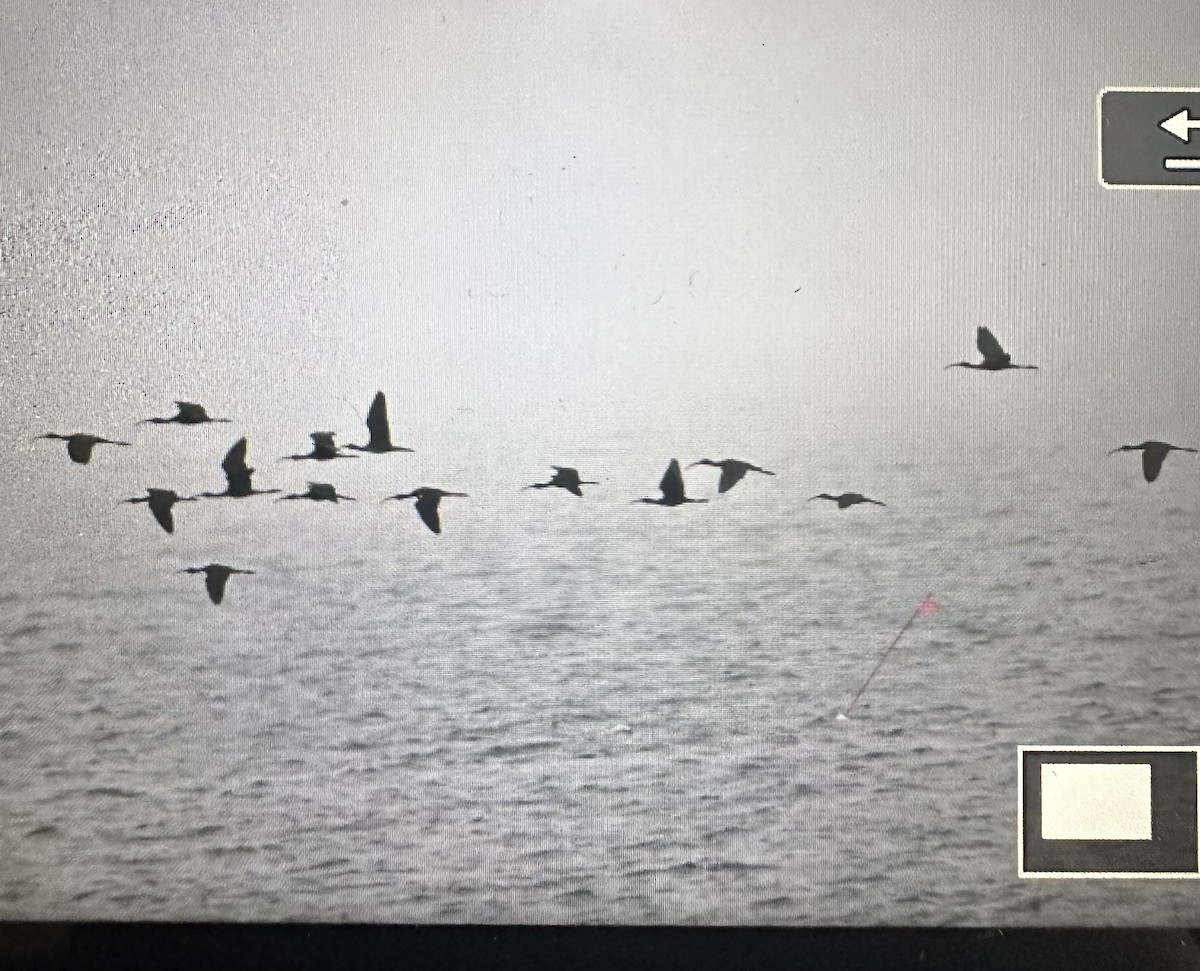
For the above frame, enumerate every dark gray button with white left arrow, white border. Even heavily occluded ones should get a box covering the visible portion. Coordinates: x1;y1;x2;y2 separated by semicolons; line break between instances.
1099;88;1200;188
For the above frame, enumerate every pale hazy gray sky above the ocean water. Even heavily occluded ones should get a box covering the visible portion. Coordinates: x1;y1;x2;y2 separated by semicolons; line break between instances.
0;0;1200;492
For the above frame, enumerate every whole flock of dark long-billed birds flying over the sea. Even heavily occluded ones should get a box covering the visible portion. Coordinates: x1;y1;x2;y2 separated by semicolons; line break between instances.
35;326;1196;604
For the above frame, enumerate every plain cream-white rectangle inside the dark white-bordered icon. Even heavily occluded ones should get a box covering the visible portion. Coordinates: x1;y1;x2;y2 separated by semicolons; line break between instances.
1042;762;1153;840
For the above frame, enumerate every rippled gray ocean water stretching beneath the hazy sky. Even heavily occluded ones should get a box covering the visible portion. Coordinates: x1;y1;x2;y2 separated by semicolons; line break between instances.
0;424;1200;925
